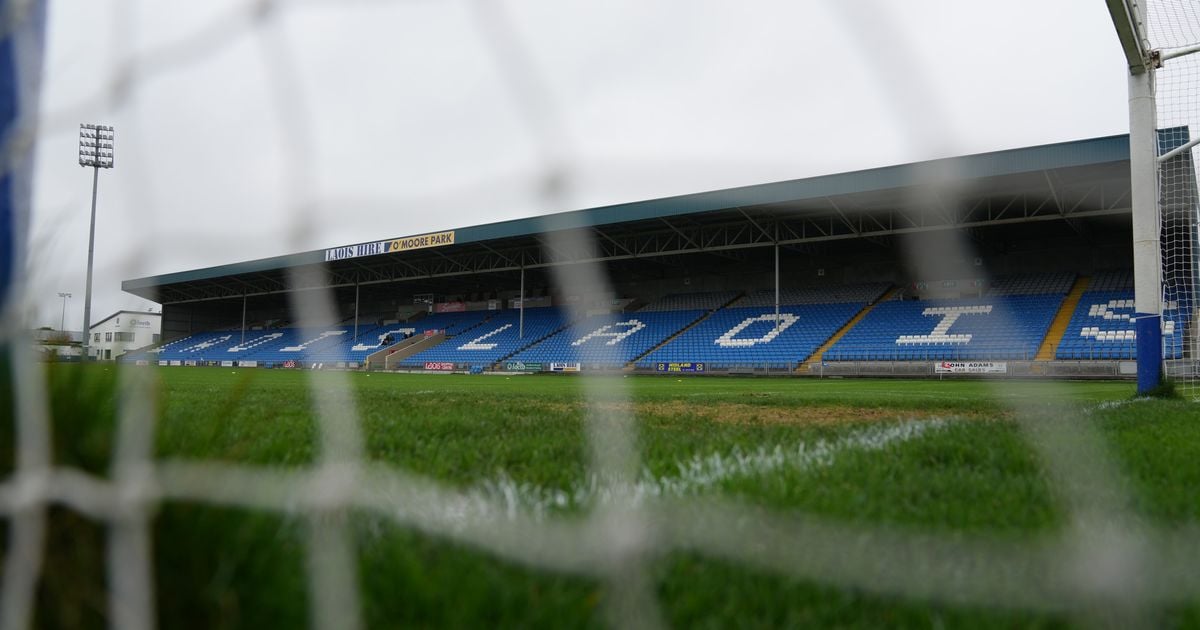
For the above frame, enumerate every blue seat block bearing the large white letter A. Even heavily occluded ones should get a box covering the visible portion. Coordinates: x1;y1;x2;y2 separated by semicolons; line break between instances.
512;310;704;368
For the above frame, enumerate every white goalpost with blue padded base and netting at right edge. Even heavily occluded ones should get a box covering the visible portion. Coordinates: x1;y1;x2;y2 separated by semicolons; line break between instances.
1108;0;1200;398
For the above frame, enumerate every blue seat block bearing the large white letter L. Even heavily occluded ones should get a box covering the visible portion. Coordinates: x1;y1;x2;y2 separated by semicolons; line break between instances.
400;307;568;368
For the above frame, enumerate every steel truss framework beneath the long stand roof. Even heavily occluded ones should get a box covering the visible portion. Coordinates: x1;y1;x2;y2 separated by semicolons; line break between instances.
157;175;1130;304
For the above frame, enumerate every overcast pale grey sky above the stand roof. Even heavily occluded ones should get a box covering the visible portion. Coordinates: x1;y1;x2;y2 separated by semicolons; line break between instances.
30;0;1128;329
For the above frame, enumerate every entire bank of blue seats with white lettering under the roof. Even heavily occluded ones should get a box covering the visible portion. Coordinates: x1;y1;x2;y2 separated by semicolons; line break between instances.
121;270;1190;370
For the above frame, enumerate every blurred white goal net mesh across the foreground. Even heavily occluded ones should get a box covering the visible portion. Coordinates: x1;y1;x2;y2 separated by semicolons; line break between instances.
0;0;1200;630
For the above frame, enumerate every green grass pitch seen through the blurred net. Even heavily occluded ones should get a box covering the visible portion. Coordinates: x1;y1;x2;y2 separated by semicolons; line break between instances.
0;366;1200;629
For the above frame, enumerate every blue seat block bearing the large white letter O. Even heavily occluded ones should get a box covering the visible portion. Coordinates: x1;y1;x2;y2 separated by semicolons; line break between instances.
637;302;864;370
